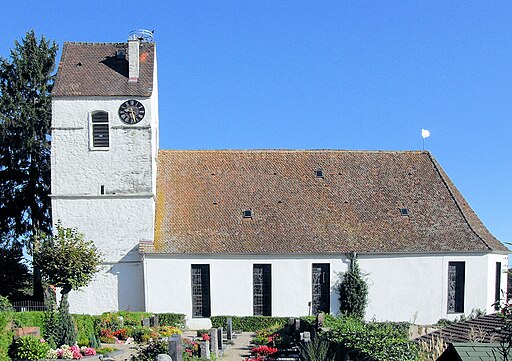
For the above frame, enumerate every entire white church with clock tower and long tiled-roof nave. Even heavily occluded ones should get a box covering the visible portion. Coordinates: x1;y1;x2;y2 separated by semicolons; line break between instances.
51;34;509;327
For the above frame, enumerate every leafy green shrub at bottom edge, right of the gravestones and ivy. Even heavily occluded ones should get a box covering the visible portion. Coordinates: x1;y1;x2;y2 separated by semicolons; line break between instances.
326;317;418;361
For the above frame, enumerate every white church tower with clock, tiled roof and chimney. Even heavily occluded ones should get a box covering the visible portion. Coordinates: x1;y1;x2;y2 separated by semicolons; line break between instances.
51;31;158;314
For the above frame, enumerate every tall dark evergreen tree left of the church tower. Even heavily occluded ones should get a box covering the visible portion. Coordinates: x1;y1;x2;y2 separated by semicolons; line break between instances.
0;30;57;300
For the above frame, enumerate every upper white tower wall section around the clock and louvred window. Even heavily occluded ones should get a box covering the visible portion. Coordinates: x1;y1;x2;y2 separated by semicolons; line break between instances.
52;97;158;195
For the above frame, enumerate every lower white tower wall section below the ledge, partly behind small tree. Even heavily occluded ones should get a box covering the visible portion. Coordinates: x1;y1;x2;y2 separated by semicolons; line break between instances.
52;196;154;314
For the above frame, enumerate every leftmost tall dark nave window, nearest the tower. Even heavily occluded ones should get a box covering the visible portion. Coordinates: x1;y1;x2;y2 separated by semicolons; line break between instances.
192;264;211;317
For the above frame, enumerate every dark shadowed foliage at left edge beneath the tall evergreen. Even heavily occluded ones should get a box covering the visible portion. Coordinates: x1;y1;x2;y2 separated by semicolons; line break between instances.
0;246;32;300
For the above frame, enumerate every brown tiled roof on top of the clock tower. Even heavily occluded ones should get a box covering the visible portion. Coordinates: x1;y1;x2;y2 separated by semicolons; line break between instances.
52;42;155;97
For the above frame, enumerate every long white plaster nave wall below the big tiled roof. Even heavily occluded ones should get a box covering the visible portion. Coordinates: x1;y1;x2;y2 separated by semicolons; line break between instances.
143;254;506;324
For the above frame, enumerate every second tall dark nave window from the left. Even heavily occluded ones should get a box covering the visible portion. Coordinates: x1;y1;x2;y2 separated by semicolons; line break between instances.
252;264;272;316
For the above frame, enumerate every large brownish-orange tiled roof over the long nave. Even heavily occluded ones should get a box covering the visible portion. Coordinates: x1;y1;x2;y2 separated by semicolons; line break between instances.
140;150;508;254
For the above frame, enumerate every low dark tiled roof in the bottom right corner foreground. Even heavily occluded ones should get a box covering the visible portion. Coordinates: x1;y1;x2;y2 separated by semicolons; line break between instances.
415;313;504;343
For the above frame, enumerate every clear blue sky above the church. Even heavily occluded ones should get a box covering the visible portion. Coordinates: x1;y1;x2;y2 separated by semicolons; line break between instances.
0;0;512;252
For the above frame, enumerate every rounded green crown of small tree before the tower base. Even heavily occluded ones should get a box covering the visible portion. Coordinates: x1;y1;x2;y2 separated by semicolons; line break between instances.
34;222;101;295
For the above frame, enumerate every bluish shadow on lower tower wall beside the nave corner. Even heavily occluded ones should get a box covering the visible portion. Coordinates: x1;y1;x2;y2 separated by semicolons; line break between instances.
107;246;144;311
